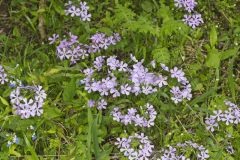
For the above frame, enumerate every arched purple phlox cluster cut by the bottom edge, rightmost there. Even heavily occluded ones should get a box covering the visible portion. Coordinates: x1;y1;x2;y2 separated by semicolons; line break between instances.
159;141;210;160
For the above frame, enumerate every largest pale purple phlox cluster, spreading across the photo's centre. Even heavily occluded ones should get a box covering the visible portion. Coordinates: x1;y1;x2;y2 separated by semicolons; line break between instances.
81;56;192;104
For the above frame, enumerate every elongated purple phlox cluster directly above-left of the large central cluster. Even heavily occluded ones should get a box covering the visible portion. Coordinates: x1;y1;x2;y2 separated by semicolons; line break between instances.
49;33;121;64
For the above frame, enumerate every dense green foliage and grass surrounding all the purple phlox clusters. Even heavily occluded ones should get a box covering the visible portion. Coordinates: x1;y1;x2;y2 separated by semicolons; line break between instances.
0;0;240;160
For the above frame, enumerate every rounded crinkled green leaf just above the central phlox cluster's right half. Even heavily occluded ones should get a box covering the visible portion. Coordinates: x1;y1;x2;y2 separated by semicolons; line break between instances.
152;48;170;64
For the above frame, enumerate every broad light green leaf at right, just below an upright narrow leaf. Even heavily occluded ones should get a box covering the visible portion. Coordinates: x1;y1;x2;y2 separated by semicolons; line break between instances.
205;48;220;68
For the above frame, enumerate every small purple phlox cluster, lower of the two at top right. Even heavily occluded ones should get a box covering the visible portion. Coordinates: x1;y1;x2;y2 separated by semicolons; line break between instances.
183;13;203;29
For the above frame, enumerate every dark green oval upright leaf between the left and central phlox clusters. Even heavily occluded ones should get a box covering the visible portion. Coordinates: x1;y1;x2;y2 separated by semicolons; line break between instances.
63;79;76;102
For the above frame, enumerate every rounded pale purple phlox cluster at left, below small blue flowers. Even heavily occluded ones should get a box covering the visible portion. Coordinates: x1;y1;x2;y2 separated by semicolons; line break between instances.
10;86;47;119
